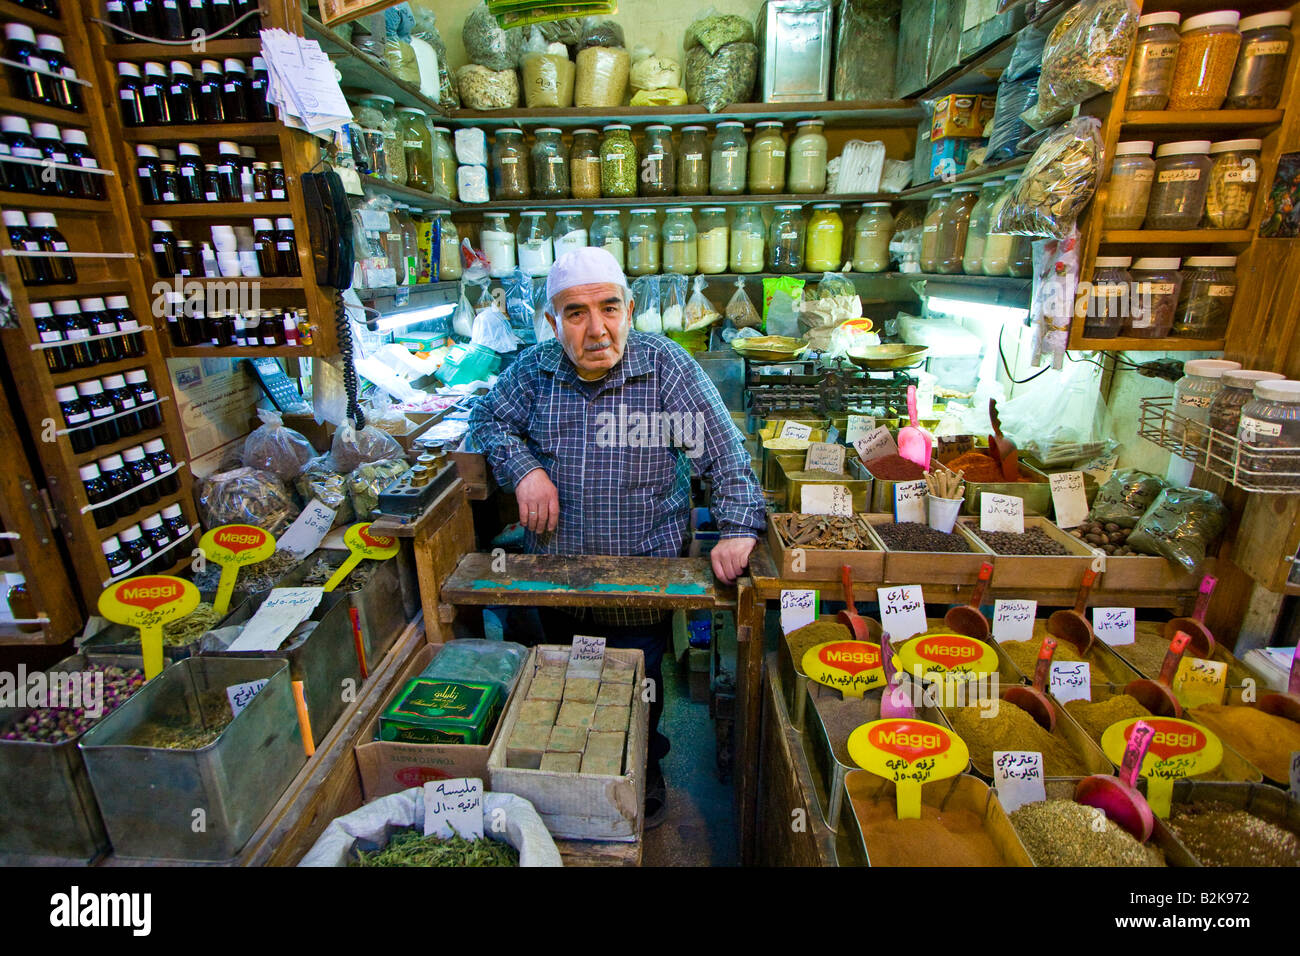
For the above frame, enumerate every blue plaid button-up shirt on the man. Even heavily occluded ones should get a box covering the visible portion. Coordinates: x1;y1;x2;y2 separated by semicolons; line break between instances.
469;330;766;558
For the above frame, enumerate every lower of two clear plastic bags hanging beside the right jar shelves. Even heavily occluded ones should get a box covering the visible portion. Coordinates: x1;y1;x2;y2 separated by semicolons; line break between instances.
989;116;1102;239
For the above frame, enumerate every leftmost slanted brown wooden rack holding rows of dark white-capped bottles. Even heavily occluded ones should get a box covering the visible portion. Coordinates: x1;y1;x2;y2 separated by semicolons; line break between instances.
0;0;196;621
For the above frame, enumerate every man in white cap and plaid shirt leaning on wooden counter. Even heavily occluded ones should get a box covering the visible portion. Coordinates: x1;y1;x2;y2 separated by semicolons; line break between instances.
469;247;766;826
